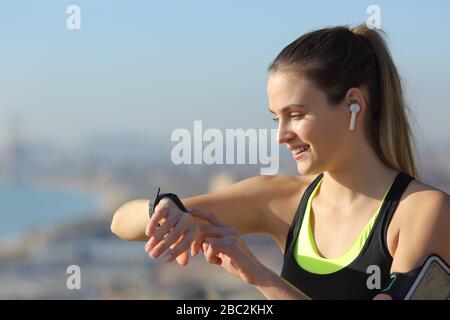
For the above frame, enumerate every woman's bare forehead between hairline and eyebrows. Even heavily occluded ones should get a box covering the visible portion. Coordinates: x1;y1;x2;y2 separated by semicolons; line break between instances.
267;71;321;109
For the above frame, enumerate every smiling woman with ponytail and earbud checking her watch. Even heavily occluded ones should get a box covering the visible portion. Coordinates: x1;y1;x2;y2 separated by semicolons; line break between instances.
112;26;450;299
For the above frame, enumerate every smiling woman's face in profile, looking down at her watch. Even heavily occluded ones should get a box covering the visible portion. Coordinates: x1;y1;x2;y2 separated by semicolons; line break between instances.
267;71;351;174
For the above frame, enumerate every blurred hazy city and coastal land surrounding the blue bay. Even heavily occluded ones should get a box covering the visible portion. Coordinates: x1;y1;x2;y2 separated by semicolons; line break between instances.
0;117;450;299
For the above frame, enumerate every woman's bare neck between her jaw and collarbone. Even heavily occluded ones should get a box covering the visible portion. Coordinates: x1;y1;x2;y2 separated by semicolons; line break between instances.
320;142;398;205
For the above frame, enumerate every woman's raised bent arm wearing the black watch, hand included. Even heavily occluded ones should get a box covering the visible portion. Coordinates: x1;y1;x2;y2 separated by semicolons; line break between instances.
111;176;307;265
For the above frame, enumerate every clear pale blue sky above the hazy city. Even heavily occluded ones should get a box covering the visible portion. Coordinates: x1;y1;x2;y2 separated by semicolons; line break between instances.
0;0;450;155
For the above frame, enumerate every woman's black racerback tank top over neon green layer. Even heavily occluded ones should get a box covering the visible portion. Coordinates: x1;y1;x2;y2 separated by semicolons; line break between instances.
281;171;414;300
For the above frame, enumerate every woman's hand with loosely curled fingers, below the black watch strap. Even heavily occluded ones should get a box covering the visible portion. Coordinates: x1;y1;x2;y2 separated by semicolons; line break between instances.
145;198;198;266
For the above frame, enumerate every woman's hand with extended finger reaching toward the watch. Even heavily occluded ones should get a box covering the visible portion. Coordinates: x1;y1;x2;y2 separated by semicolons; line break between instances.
191;210;267;285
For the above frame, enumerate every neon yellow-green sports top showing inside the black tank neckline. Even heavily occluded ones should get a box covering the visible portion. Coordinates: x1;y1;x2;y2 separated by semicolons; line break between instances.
294;177;392;274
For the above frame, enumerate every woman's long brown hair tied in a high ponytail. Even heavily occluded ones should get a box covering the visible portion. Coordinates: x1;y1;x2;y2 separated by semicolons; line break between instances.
268;25;419;179
